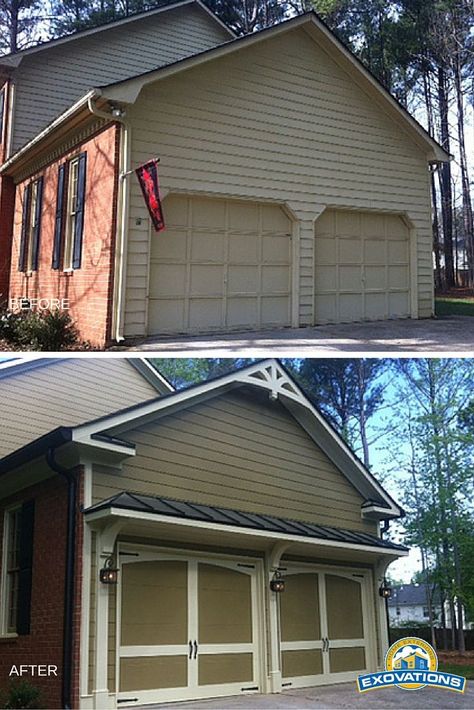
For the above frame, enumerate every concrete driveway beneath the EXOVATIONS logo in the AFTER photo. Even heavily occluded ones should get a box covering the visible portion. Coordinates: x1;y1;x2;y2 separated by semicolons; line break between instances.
132;681;474;710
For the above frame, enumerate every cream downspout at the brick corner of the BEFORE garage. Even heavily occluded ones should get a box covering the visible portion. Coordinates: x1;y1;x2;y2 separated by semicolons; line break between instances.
87;96;131;342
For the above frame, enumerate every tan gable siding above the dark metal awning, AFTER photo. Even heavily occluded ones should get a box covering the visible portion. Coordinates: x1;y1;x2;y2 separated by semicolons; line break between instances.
93;393;376;532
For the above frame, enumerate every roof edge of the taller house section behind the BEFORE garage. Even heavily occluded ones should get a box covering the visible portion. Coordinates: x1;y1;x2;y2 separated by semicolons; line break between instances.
0;0;231;67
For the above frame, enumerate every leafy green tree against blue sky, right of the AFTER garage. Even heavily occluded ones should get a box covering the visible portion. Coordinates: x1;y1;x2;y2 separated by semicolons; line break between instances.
392;358;474;651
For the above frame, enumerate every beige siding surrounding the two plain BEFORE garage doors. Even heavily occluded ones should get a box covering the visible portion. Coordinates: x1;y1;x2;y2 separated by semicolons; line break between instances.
125;28;432;335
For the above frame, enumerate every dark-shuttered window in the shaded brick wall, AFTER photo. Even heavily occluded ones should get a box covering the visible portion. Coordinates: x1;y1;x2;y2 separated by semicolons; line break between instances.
0;500;35;635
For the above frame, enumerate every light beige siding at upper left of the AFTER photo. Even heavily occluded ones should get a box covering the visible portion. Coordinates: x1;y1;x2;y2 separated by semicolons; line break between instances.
0;358;159;456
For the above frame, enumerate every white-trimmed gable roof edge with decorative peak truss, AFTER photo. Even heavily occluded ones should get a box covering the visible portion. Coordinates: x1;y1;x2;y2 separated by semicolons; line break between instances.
0;359;403;519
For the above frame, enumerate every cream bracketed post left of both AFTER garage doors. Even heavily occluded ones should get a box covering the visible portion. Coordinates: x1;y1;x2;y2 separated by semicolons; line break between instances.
92;522;123;710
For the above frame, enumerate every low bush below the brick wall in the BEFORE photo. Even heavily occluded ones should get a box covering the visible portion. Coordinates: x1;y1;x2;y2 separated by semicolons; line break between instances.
0;311;80;352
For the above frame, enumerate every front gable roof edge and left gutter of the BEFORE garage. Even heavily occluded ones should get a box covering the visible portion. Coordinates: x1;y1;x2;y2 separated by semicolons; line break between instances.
0;11;450;173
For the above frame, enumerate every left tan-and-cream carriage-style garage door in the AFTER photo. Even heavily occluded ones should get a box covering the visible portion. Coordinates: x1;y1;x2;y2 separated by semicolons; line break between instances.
119;553;261;705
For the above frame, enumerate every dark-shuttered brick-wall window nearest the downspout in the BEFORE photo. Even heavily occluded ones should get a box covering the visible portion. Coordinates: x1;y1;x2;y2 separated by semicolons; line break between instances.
52;153;86;271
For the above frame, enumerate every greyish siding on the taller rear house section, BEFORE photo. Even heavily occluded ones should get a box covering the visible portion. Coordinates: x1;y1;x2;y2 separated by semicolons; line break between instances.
13;6;230;151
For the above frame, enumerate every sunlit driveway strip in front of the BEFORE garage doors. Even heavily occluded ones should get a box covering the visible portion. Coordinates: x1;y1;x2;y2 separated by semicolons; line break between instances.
120;316;474;357
